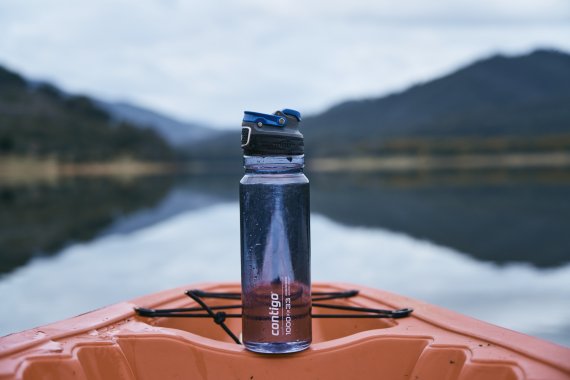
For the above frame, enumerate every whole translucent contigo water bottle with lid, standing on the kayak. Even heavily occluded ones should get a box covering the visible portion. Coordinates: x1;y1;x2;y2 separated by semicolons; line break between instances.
240;109;311;354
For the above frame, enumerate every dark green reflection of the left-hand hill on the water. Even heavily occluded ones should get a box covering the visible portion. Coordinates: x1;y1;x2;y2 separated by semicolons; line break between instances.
0;177;173;274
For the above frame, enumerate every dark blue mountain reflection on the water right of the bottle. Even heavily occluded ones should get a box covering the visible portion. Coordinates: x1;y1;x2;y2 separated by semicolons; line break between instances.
311;171;570;267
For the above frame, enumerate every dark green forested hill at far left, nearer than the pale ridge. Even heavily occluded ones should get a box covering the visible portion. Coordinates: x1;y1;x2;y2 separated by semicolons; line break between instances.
0;66;173;162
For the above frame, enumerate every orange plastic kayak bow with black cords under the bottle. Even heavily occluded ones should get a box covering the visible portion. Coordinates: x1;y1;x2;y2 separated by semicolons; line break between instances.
0;283;570;380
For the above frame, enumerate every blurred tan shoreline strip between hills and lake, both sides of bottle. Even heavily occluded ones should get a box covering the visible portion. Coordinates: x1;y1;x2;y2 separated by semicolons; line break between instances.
0;151;570;185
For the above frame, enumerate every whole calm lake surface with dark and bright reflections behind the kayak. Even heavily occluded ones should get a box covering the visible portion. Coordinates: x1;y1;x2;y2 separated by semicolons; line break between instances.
0;171;570;346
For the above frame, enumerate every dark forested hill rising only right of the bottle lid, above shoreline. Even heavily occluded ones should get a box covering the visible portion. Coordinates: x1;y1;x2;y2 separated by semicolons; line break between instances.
303;50;570;154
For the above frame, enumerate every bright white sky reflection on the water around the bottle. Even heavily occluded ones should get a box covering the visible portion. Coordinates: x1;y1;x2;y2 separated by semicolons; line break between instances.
0;202;570;346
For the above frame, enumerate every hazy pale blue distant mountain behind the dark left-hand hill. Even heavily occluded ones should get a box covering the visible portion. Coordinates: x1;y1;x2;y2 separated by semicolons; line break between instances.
97;101;219;147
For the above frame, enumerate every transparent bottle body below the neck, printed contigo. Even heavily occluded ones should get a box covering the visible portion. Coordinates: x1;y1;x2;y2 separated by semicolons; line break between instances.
240;179;311;353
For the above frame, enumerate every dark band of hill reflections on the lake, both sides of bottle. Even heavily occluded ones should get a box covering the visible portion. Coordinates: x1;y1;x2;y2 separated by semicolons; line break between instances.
0;171;570;275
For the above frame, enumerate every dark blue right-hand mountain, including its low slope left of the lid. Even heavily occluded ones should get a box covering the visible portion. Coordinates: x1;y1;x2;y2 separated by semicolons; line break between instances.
193;50;570;163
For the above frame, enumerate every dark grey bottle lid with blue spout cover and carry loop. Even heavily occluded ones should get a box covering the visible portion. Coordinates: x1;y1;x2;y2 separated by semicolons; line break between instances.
241;108;304;156
